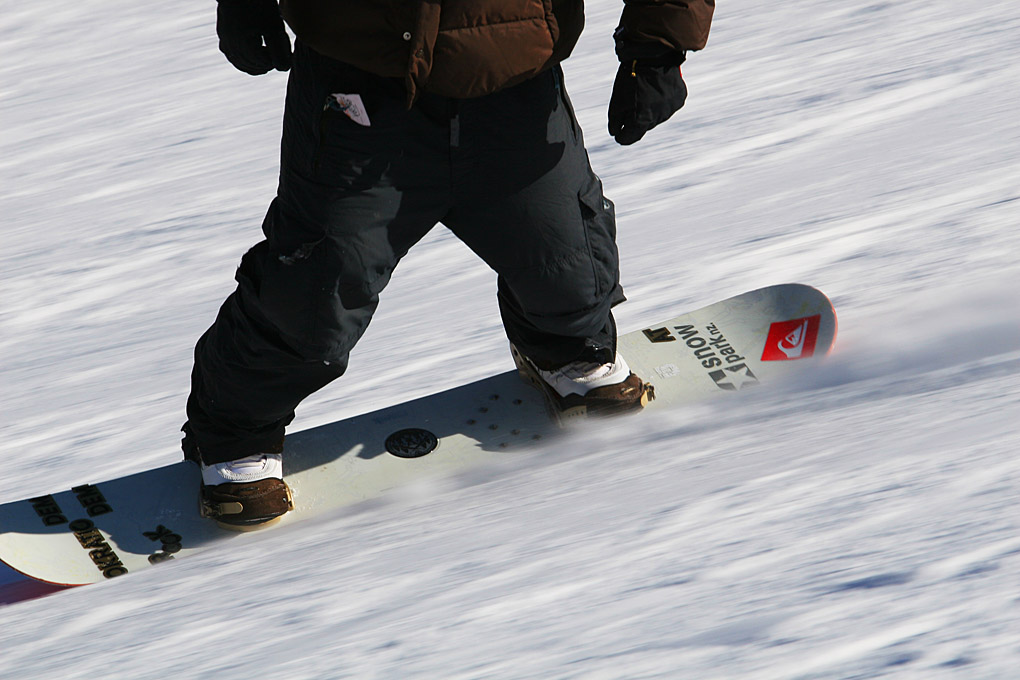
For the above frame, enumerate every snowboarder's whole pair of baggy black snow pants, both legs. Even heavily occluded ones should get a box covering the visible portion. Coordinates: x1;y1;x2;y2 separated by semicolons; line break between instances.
186;43;623;464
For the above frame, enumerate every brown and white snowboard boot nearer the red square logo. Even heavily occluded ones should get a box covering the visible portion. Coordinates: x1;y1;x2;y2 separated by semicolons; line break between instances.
510;345;655;423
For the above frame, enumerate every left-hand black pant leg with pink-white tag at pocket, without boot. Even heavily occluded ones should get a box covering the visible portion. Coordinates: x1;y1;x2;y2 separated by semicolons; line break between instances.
186;45;448;479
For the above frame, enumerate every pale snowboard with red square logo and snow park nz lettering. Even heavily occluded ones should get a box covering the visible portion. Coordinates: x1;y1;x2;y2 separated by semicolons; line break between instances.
0;283;836;585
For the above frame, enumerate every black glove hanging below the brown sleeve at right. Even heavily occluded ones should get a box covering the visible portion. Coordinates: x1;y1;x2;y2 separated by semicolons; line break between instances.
609;44;687;145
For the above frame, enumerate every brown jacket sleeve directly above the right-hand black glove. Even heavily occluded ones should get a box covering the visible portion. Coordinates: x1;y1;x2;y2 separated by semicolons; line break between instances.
616;0;715;51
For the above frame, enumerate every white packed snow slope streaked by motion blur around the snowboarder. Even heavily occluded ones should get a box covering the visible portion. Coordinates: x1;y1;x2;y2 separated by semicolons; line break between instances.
0;0;1020;680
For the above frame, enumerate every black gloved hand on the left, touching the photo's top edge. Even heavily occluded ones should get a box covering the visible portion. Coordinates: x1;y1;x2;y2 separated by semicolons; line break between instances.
216;0;291;75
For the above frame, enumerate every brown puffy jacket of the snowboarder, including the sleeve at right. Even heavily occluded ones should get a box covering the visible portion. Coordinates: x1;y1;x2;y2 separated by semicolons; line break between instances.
279;0;715;102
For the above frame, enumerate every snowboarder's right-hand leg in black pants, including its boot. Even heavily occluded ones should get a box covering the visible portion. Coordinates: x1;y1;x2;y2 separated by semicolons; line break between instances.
444;68;652;413
